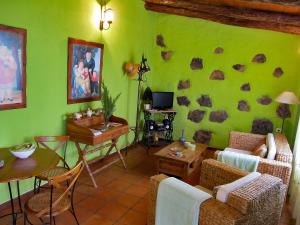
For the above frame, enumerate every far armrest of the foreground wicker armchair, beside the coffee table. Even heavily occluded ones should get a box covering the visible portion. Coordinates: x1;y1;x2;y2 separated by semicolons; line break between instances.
200;159;248;190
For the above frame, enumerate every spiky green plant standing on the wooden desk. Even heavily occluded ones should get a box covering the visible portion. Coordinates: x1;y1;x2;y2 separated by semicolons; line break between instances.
101;82;121;128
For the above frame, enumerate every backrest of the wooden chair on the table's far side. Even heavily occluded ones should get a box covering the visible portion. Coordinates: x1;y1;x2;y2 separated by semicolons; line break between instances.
34;136;70;168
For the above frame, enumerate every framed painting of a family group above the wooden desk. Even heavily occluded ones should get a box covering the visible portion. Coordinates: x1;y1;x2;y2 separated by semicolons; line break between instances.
68;38;104;104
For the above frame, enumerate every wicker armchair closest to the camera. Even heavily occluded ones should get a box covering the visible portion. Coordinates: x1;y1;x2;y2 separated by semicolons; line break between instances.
148;159;287;225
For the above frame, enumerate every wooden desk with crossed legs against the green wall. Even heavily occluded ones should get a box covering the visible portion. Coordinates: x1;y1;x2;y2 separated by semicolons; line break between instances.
67;115;129;188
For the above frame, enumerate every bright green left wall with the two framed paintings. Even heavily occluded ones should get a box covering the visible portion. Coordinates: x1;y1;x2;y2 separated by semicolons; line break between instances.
0;0;156;202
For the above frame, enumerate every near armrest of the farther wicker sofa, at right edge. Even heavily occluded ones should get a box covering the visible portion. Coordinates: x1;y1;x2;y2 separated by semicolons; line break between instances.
257;158;292;185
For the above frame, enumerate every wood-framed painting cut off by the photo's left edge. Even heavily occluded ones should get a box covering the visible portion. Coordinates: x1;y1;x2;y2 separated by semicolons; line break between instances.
0;25;27;110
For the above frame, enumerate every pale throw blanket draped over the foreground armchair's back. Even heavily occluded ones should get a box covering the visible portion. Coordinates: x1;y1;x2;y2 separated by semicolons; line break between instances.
155;177;212;225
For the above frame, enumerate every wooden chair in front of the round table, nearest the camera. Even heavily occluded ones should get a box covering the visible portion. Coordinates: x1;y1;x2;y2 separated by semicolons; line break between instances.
24;161;83;225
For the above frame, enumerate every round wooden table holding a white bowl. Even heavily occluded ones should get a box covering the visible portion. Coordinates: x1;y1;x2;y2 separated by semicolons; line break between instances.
0;148;60;224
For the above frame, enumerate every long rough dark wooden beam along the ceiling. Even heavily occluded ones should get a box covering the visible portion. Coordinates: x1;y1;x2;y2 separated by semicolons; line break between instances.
145;0;300;34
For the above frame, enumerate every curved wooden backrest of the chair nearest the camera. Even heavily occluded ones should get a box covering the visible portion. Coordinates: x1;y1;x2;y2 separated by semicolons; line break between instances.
37;161;84;217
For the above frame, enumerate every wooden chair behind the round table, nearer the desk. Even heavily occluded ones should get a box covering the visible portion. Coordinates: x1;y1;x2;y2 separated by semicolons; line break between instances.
34;136;70;193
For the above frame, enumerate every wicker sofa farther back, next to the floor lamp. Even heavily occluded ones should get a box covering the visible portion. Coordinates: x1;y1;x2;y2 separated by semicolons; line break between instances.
215;131;293;185
